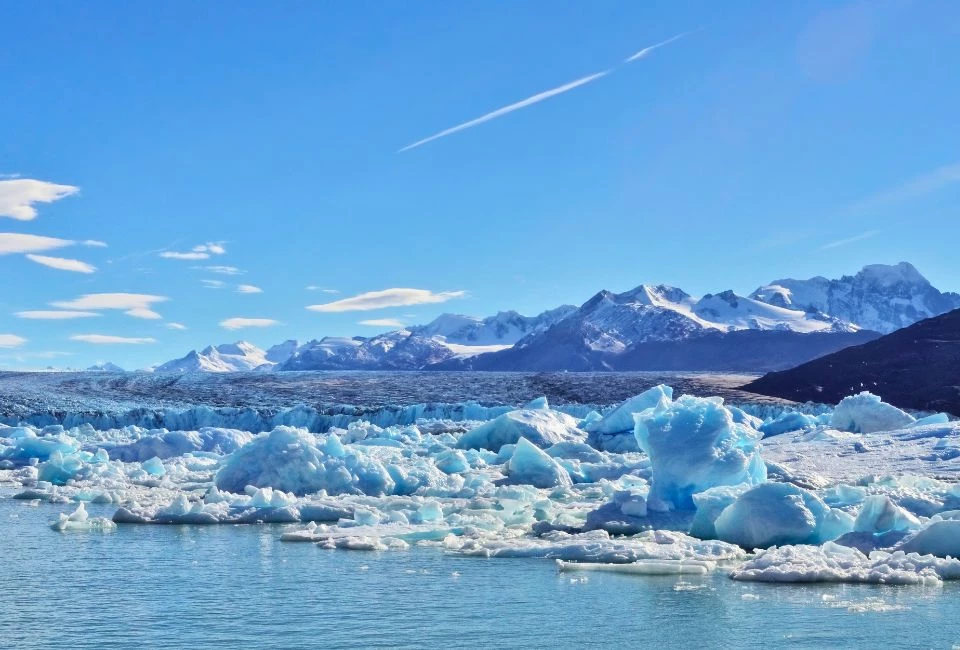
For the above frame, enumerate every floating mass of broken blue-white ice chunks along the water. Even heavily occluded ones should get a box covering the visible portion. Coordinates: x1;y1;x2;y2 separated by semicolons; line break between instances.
0;386;960;584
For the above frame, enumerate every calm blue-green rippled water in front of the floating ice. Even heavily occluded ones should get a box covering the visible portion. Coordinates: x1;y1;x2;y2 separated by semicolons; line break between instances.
0;494;960;649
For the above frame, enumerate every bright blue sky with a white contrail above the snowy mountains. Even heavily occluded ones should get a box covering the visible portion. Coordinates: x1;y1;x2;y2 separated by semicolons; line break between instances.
0;1;960;368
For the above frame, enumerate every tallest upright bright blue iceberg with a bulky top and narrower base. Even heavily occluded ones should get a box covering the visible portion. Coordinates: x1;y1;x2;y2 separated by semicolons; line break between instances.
634;395;767;510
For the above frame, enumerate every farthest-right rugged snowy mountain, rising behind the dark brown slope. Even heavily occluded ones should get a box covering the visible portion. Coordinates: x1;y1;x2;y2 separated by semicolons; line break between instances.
750;262;960;334
